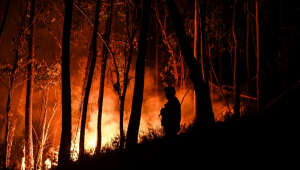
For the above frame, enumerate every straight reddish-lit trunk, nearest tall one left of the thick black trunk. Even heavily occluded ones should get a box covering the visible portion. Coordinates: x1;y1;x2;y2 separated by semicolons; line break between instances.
25;0;35;169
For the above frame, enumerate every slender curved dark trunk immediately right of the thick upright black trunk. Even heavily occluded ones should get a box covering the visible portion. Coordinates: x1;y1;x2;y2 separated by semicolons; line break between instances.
79;0;101;158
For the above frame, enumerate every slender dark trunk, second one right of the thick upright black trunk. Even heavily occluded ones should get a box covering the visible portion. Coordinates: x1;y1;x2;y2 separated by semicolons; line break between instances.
96;0;114;153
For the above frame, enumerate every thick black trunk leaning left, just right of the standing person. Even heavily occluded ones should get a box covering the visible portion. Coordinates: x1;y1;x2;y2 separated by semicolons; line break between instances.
166;0;215;127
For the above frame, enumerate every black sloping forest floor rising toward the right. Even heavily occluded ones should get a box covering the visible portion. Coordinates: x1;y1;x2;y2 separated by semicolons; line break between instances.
64;99;298;169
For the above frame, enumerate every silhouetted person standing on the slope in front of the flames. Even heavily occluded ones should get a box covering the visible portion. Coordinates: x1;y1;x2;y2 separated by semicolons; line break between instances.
160;87;181;139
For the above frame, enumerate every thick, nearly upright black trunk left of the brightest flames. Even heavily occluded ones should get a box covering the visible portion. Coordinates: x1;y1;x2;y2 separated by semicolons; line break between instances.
58;0;73;168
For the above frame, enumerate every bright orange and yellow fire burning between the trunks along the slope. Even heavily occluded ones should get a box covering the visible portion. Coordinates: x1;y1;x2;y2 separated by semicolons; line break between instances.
1;67;238;170
